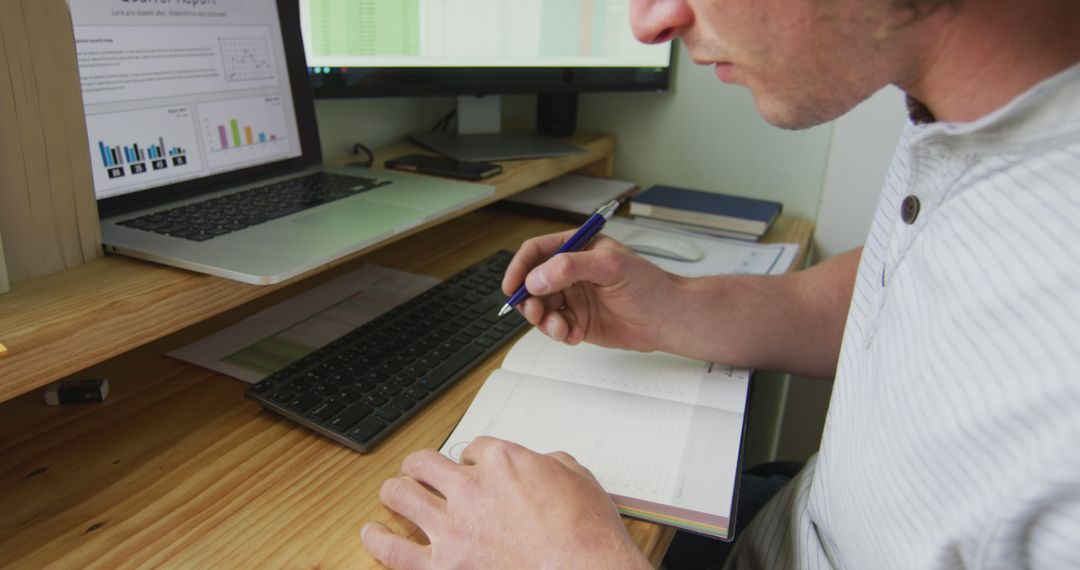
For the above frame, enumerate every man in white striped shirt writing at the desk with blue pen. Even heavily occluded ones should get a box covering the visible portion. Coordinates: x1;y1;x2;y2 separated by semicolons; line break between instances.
361;0;1080;569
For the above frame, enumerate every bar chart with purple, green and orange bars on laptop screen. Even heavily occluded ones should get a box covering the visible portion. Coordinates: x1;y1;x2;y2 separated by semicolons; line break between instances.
198;96;289;168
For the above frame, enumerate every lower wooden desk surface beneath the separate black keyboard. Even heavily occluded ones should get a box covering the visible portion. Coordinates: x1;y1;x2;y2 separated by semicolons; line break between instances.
0;208;812;568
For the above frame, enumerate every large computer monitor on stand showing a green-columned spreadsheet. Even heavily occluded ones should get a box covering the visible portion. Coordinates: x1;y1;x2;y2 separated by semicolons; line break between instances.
300;0;672;160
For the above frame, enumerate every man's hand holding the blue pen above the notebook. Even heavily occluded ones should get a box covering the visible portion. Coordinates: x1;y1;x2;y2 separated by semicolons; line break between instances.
502;231;686;351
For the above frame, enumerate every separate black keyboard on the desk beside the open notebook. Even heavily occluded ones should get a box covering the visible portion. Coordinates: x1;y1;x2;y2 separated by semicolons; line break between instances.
246;250;528;452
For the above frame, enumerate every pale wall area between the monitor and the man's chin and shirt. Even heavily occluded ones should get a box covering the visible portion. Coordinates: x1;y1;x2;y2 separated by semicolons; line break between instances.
578;48;832;219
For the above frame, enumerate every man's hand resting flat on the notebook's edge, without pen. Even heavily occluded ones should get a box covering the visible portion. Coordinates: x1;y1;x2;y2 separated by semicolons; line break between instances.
360;437;650;569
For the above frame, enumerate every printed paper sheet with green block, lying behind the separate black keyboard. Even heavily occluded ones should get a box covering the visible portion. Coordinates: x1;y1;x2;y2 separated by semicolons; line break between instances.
168;264;440;383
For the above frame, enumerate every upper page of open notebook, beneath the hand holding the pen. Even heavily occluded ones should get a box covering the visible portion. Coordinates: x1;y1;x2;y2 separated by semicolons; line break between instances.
502;328;750;413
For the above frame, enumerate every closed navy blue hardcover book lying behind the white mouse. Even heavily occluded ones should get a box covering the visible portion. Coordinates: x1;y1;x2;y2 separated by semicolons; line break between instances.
630;186;783;236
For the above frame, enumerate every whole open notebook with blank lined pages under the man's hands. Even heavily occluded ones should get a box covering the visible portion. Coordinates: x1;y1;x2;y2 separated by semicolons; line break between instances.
441;329;750;540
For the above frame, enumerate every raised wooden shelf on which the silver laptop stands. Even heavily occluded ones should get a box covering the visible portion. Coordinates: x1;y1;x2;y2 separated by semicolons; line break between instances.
0;134;615;402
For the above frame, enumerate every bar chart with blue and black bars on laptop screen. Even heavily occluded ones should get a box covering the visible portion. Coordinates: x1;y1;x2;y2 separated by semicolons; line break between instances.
86;105;203;198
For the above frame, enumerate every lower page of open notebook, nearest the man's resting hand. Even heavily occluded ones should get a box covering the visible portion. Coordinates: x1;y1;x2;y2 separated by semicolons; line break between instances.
442;369;742;517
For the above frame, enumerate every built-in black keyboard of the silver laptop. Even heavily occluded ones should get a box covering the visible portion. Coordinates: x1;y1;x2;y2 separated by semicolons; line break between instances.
117;173;390;242
